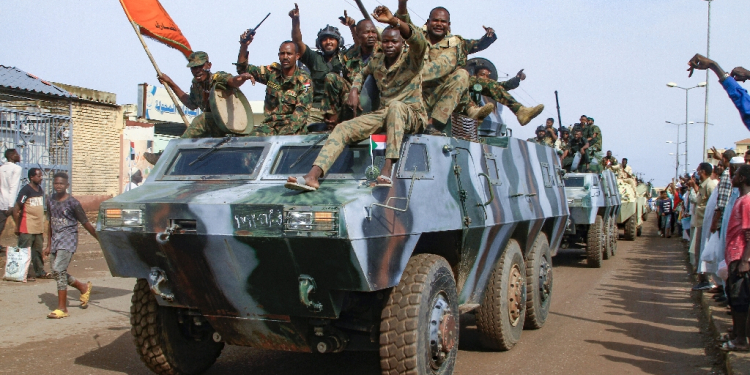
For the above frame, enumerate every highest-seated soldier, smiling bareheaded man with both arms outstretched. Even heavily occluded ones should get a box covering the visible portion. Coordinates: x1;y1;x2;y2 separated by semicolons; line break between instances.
396;0;497;134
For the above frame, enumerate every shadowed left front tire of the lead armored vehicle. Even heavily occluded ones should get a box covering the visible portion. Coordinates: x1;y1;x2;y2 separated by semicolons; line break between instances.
130;279;224;375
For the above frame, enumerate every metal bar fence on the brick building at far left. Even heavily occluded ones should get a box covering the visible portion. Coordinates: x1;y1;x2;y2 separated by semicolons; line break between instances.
0;101;73;194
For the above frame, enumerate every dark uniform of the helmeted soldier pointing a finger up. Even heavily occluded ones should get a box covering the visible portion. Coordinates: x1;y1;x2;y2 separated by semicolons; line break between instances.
299;45;344;124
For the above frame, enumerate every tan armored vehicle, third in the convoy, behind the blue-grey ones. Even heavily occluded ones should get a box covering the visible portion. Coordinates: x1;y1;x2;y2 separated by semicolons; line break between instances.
617;170;649;241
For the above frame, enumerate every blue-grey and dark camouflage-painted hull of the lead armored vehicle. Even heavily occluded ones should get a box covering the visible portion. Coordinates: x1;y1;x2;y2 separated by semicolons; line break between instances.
97;135;568;351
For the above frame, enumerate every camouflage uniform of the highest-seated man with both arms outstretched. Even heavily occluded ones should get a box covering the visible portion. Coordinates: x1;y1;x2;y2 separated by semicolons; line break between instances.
396;13;494;124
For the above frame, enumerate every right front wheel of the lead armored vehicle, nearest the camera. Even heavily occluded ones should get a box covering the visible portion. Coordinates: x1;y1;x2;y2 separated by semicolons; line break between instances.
380;254;459;375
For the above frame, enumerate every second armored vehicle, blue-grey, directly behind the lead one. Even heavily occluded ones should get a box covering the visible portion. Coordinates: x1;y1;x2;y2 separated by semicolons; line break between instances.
561;170;620;268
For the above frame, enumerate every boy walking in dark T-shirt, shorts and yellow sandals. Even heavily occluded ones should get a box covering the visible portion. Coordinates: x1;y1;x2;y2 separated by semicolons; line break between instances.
44;172;99;319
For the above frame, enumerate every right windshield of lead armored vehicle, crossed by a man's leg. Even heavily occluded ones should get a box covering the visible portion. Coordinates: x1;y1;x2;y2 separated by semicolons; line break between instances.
271;145;372;177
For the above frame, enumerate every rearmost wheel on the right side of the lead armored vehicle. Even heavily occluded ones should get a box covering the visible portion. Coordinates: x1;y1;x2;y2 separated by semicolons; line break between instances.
523;232;552;329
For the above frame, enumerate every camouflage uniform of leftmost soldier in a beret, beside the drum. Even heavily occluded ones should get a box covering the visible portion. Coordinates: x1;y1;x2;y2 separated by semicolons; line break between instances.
181;72;232;138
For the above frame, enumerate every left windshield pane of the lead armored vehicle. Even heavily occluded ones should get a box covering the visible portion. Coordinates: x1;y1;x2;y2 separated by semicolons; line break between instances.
165;147;263;176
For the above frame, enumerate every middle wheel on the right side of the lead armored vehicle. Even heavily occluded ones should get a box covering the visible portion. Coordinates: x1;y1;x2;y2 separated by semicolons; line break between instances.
476;240;527;350
